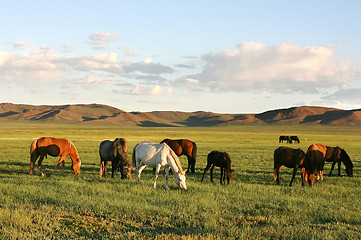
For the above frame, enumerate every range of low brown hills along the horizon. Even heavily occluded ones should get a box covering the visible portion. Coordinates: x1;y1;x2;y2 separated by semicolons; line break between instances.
0;103;361;127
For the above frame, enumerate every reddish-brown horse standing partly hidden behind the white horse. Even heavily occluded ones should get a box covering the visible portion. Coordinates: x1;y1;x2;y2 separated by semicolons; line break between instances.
160;138;197;173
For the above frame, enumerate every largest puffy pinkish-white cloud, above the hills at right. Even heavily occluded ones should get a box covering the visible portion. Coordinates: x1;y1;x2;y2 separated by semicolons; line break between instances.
178;42;352;93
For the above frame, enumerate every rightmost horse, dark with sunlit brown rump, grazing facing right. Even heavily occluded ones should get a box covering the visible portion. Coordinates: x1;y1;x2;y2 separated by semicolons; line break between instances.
308;144;353;179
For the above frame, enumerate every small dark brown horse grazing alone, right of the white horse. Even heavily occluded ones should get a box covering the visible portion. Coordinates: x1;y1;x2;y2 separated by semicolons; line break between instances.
202;151;233;184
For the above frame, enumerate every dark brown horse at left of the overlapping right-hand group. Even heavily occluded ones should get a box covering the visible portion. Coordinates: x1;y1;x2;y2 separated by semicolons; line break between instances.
273;147;306;186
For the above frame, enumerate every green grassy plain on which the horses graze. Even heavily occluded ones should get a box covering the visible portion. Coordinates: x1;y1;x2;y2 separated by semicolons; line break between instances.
0;123;361;239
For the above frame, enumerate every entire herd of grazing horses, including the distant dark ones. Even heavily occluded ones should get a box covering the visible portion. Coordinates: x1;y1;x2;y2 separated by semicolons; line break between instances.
30;136;353;189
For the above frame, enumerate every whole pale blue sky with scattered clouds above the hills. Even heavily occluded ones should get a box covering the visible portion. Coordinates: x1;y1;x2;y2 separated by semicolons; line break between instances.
0;0;361;113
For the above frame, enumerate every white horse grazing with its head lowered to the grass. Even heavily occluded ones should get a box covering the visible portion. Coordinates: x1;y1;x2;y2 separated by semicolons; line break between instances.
133;141;187;190
